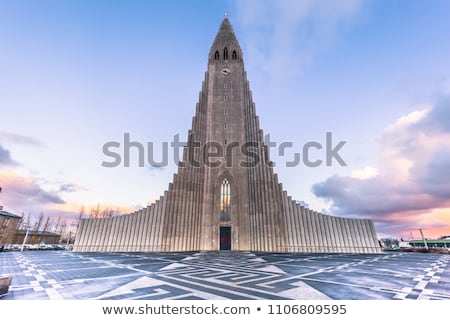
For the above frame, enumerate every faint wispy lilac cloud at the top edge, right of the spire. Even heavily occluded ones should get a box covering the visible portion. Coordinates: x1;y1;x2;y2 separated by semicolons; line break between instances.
235;0;363;79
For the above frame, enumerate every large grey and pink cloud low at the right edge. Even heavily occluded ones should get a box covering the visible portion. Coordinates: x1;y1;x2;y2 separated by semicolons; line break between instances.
312;99;450;238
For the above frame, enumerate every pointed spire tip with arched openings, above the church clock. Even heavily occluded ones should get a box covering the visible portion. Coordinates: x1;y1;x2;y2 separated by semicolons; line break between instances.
209;14;242;63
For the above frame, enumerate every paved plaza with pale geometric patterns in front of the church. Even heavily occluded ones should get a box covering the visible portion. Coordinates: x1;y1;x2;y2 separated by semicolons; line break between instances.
0;251;450;300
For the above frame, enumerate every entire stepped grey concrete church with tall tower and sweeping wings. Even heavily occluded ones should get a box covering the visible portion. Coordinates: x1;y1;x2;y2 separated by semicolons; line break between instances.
74;18;380;253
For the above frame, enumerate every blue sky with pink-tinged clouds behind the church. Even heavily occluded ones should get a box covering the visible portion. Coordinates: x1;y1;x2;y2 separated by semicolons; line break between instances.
0;0;450;239
